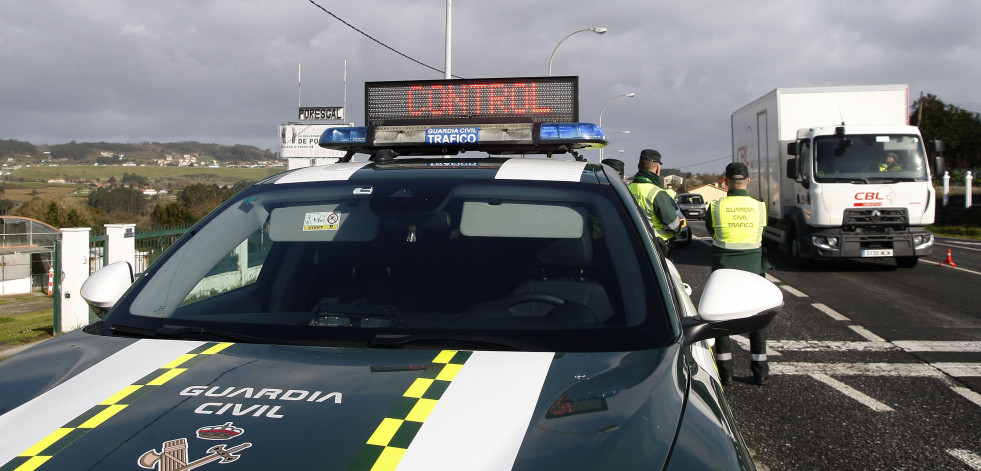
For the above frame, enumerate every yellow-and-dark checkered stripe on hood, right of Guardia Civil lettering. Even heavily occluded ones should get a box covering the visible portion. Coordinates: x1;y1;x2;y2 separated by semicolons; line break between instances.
348;350;473;471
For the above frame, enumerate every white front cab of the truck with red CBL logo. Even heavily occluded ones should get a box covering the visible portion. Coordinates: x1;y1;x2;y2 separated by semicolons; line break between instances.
782;125;935;267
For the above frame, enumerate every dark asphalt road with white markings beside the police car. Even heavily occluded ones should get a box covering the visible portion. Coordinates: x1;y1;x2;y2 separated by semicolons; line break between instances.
673;227;981;471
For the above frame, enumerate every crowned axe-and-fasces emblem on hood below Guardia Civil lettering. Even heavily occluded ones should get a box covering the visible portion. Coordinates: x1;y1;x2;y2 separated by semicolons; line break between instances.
136;422;252;471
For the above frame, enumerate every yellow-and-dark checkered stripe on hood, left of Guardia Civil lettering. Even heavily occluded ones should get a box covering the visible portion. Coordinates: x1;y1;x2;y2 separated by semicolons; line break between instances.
0;342;232;471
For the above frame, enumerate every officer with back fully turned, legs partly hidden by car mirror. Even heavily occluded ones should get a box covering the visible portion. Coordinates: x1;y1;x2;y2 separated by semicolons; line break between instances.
705;162;771;386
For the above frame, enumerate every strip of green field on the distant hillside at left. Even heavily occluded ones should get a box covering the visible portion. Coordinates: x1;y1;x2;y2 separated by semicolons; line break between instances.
8;165;286;185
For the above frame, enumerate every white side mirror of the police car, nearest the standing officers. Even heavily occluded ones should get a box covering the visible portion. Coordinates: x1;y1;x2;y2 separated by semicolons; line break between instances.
683;268;783;344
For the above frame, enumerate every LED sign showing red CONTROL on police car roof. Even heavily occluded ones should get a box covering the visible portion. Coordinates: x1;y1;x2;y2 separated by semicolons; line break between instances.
365;77;579;126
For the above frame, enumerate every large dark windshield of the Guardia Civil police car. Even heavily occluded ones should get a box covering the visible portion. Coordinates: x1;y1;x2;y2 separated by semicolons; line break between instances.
106;171;675;351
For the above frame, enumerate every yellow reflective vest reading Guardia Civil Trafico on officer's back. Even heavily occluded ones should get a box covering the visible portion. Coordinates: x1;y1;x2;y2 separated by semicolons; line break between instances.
709;195;766;250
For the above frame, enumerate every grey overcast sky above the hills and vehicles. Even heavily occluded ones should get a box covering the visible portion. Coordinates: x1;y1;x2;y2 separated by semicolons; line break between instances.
0;0;981;173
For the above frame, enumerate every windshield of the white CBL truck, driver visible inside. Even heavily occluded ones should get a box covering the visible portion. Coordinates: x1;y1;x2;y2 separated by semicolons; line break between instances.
814;134;929;183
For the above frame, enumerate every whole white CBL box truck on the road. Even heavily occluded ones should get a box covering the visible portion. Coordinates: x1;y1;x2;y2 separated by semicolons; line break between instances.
732;85;936;268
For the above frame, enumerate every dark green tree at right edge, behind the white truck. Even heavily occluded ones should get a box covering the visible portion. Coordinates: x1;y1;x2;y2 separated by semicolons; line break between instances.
910;94;981;168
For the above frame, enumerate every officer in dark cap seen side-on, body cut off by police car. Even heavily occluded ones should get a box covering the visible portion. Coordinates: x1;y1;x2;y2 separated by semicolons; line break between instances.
627;149;684;254
